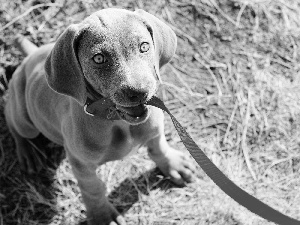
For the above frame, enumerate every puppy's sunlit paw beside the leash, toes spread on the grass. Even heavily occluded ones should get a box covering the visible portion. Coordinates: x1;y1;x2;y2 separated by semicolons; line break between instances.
151;148;196;186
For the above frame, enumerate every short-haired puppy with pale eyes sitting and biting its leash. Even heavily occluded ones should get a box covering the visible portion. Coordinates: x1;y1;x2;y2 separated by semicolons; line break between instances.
5;8;195;225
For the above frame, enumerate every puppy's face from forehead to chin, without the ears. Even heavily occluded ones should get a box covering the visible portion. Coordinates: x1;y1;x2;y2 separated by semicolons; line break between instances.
77;13;158;124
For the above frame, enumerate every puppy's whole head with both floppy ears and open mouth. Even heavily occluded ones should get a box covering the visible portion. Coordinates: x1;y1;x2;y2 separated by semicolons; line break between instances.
45;9;176;124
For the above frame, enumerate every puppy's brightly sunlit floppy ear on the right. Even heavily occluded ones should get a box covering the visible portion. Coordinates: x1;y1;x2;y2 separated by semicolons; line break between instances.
134;9;177;68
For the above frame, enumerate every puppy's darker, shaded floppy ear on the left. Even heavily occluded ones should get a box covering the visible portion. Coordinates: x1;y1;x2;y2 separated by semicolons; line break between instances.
45;24;86;105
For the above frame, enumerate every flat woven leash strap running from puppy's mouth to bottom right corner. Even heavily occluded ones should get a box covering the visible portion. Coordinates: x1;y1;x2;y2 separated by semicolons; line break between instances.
146;96;300;225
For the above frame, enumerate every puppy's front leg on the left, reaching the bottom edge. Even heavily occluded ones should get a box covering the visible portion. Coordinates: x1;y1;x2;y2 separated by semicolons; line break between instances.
68;154;126;225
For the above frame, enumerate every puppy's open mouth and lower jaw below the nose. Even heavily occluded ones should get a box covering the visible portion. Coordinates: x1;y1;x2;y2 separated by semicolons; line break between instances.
116;104;150;125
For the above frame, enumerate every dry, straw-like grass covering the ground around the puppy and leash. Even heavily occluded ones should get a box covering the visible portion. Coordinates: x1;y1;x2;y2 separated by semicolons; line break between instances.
0;0;300;225
